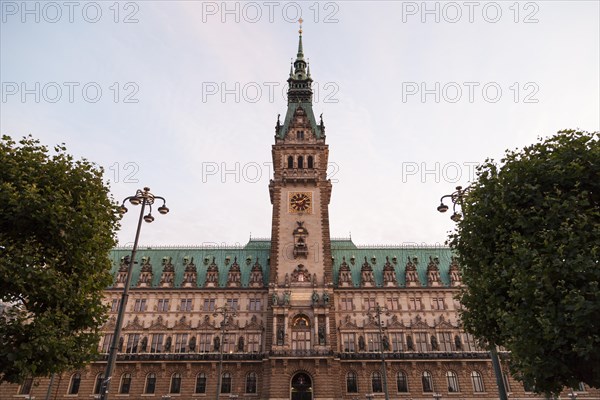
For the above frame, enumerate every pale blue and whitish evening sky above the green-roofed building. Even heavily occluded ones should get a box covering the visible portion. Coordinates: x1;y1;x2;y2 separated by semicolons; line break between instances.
0;0;600;245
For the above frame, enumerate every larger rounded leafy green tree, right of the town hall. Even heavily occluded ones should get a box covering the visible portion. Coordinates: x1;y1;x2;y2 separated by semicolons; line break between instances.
450;130;600;394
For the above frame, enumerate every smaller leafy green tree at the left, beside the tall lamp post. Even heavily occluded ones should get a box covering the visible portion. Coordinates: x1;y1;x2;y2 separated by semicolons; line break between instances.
0;136;119;382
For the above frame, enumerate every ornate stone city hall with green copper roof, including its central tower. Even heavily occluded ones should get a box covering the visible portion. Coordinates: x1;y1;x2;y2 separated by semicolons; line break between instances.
0;30;599;400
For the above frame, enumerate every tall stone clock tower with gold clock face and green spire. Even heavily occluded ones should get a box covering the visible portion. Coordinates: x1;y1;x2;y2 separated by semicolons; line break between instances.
267;21;336;351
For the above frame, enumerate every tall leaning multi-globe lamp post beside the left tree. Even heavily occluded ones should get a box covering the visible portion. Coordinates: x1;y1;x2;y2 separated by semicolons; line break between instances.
100;187;169;400
